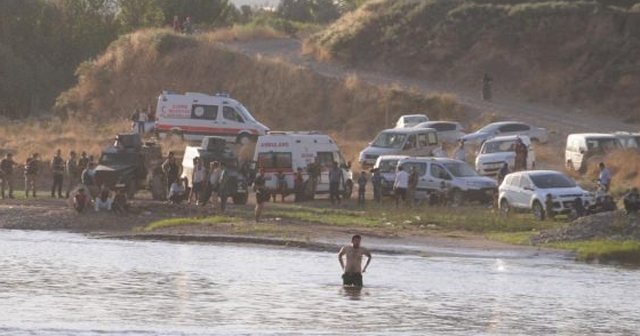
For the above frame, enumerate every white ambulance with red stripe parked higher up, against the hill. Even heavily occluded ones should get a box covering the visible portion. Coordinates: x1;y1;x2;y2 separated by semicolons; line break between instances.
156;91;269;144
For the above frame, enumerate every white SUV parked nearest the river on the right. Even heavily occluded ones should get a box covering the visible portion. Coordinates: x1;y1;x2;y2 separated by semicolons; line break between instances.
498;170;594;220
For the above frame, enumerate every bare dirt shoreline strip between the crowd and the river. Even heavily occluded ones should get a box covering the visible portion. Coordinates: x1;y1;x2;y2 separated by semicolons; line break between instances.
0;197;571;258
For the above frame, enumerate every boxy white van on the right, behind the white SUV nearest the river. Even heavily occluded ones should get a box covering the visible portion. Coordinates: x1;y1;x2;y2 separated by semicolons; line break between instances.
564;133;622;173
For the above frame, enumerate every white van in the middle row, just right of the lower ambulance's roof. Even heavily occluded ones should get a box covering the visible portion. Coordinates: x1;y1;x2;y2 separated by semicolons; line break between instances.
358;128;443;168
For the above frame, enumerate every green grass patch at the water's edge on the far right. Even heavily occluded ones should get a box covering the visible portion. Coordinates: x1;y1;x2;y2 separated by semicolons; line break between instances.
545;240;640;265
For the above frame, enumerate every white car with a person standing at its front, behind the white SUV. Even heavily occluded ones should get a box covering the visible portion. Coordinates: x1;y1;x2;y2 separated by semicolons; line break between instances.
476;135;536;177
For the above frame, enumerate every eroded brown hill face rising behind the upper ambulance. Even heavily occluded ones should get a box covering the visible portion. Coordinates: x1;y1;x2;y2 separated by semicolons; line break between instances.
57;30;463;140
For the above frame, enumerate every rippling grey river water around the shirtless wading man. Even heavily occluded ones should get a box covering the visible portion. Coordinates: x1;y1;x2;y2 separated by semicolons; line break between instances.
0;231;640;335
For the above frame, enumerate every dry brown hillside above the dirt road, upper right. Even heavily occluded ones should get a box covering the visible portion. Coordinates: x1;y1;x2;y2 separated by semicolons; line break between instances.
305;0;640;121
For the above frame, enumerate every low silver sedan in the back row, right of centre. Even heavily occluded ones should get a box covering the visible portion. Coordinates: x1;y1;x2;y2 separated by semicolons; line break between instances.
462;121;548;145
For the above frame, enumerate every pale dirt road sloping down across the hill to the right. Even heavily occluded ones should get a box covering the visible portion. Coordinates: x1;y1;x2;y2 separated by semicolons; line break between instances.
224;39;640;138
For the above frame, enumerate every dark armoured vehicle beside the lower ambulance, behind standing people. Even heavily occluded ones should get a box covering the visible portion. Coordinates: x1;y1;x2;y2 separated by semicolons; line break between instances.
182;136;249;204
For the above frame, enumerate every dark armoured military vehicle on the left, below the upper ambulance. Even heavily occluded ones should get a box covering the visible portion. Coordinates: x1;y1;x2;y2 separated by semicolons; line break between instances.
95;133;167;200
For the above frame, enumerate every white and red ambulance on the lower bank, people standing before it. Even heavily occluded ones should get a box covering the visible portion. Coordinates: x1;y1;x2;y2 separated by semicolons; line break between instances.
254;132;353;198
